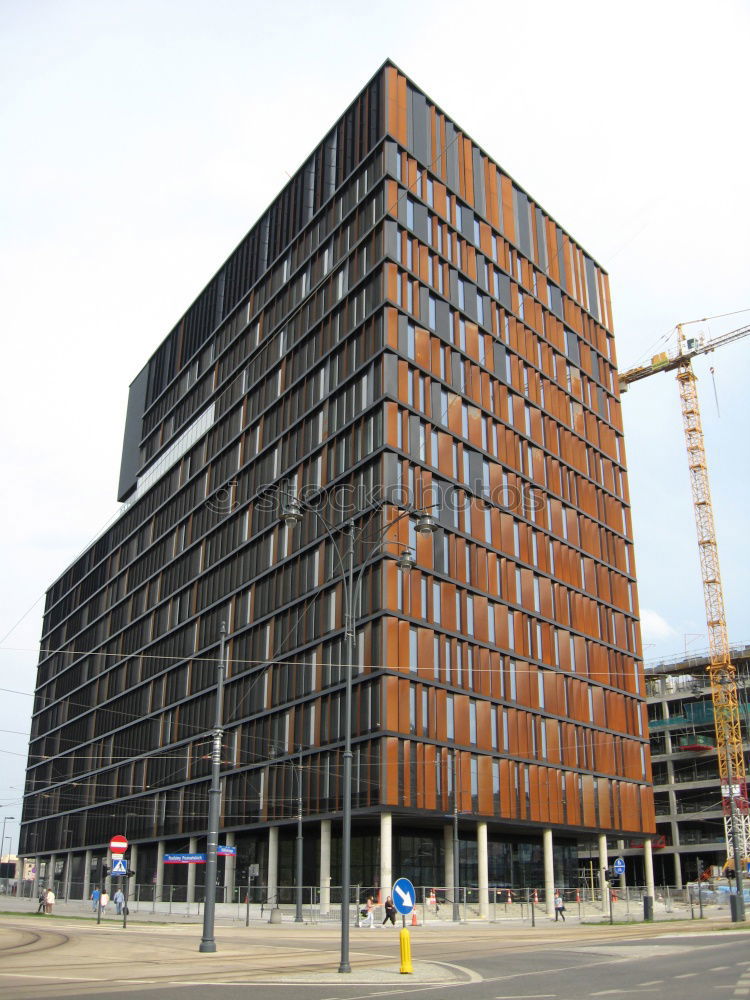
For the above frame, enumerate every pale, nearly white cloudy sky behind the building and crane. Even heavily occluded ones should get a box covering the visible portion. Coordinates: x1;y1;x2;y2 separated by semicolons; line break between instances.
0;0;750;850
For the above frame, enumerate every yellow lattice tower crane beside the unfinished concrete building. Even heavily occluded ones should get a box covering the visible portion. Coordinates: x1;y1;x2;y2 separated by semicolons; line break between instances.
619;320;750;871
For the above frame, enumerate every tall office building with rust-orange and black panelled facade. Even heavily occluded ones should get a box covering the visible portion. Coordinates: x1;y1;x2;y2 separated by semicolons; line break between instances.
21;63;654;904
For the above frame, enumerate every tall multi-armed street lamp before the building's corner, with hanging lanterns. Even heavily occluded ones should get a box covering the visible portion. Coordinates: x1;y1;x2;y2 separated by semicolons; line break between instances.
281;494;436;972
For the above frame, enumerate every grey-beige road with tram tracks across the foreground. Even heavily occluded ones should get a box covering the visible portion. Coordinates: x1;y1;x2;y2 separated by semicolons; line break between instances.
0;917;750;1000
